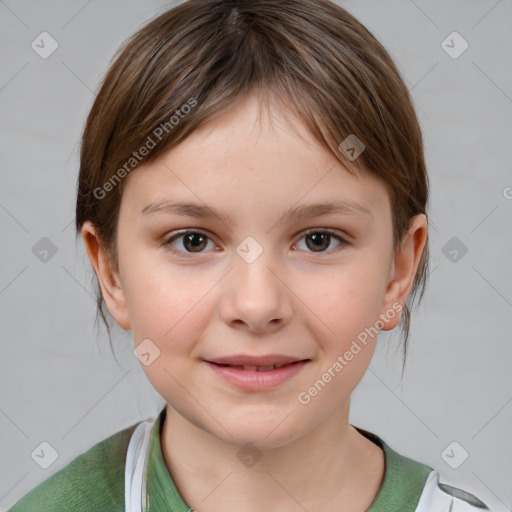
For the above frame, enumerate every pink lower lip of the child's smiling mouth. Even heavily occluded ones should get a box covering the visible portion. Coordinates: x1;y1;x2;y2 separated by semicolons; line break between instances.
206;361;308;391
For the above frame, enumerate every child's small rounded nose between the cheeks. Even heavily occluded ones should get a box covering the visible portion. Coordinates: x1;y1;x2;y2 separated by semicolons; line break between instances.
221;245;293;334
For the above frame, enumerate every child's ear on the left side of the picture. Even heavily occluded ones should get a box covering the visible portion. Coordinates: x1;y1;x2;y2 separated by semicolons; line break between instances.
81;221;131;330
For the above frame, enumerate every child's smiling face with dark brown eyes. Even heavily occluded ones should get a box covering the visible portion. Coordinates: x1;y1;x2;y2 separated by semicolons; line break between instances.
85;92;428;448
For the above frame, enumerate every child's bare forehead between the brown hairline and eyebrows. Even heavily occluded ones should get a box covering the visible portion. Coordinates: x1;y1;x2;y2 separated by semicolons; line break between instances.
119;96;388;225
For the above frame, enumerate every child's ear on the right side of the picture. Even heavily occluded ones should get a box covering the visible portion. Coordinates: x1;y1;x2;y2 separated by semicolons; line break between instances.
380;214;428;331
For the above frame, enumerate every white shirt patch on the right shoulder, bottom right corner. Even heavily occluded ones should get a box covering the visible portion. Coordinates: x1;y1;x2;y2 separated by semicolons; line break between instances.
416;470;490;512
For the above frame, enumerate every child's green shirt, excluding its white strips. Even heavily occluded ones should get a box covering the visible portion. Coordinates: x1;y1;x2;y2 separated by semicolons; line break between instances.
8;407;432;512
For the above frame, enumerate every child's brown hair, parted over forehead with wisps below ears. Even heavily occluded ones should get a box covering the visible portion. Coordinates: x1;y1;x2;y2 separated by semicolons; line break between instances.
76;0;429;372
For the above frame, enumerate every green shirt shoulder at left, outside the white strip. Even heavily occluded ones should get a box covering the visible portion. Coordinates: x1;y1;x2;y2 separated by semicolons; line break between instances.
8;424;137;512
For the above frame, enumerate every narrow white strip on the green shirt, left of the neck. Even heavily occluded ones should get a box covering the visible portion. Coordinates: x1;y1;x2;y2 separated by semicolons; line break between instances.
124;420;155;512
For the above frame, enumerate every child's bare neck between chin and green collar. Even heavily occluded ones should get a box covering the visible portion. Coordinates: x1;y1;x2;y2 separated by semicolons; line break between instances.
161;401;384;512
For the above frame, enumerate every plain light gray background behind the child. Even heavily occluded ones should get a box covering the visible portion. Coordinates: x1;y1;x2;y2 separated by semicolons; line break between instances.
0;0;512;512
